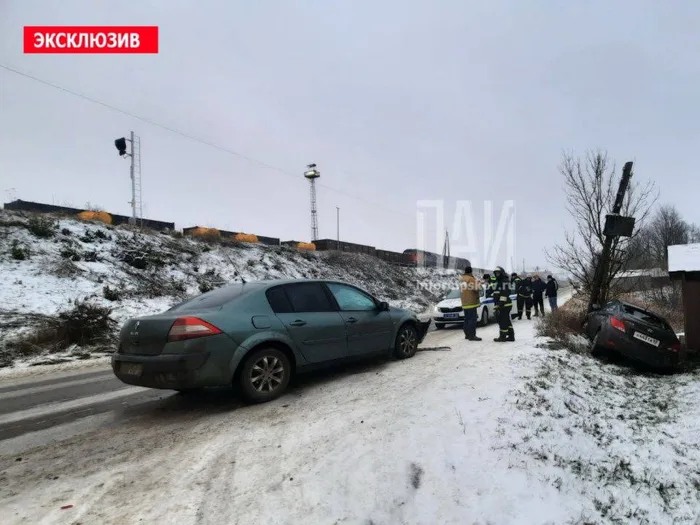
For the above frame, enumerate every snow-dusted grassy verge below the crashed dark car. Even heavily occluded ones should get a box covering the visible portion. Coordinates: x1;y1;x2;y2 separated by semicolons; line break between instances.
502;349;700;524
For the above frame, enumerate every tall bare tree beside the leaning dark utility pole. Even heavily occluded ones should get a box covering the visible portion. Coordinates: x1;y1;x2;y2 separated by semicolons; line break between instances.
546;150;658;301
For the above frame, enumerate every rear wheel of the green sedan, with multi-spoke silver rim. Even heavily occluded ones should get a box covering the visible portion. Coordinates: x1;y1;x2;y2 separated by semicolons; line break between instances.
238;347;292;403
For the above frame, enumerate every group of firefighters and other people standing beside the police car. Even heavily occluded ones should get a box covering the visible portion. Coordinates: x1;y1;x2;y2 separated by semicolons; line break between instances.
459;266;559;343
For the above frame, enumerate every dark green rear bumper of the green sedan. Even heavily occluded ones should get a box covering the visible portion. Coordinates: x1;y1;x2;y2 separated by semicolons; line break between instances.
112;352;209;390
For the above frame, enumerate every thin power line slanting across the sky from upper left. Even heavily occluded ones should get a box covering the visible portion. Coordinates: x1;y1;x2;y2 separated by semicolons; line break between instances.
0;64;414;218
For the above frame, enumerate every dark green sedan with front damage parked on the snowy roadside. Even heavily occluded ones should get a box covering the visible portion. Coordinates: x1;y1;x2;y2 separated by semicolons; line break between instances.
112;279;430;403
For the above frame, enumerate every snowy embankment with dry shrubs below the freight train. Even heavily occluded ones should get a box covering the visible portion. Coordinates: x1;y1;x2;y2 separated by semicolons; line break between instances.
0;211;442;367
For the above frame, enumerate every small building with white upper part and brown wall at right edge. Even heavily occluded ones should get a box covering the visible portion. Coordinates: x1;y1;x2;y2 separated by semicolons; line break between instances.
668;243;700;352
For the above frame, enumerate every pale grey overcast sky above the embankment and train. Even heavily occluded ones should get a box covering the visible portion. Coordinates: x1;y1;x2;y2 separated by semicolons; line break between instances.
0;0;700;267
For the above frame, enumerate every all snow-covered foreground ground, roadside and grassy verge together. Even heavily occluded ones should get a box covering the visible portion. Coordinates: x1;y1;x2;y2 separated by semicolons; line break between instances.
0;290;700;525
